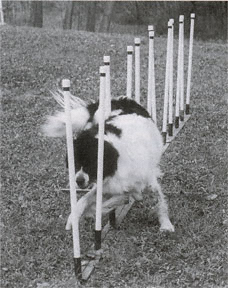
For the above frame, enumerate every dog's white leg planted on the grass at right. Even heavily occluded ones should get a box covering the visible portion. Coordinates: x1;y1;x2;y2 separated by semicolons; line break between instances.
151;178;174;232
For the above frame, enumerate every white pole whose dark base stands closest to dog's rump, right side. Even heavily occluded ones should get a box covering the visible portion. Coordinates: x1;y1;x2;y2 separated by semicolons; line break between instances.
162;22;172;144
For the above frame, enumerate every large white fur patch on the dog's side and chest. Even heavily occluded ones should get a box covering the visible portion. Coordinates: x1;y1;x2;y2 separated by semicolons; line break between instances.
105;114;163;194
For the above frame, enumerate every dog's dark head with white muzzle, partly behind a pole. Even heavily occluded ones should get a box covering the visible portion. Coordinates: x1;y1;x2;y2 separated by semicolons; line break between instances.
74;126;119;189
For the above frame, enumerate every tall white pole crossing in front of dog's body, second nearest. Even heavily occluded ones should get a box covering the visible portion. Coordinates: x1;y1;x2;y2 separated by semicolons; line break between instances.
95;66;106;250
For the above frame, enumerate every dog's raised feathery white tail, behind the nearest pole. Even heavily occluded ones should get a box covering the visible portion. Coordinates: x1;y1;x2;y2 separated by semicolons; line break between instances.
41;90;90;137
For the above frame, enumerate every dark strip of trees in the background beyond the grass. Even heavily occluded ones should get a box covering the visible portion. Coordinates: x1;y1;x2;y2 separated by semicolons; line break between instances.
0;0;227;39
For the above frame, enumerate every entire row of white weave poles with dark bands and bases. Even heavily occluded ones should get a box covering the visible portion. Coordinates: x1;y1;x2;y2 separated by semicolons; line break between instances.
62;13;195;281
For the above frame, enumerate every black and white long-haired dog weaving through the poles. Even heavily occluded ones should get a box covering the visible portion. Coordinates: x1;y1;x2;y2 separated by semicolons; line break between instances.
43;92;174;232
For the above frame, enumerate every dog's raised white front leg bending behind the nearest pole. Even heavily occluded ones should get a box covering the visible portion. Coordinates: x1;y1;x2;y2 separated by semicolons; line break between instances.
66;185;97;230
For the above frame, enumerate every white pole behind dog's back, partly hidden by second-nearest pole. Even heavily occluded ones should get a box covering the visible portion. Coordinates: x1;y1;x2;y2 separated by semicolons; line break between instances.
104;56;111;119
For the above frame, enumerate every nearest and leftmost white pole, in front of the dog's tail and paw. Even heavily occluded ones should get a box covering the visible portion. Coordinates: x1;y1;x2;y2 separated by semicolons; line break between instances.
62;79;82;280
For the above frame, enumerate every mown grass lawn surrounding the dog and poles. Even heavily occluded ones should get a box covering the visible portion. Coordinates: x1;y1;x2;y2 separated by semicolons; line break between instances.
1;26;228;288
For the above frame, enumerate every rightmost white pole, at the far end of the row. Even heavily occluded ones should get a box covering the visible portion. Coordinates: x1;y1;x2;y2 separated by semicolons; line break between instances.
186;13;195;114
